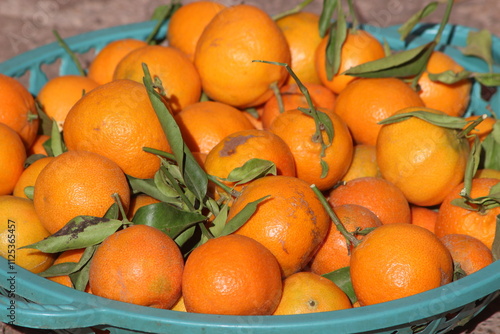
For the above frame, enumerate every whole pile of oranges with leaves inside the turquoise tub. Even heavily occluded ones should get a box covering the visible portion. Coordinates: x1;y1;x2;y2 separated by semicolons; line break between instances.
0;1;500;315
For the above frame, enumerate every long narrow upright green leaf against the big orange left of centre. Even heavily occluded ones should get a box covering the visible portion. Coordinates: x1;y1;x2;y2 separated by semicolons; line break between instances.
143;64;208;201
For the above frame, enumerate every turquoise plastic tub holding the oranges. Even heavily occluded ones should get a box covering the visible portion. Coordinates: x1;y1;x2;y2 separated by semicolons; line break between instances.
0;22;500;334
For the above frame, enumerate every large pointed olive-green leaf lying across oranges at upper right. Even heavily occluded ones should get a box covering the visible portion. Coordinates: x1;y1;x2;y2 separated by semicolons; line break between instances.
343;42;436;78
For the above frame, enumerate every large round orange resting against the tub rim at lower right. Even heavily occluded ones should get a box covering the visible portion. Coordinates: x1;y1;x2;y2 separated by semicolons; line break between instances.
350;224;453;306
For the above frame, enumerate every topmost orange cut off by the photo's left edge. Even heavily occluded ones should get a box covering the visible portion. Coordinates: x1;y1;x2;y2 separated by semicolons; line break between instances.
0;73;40;148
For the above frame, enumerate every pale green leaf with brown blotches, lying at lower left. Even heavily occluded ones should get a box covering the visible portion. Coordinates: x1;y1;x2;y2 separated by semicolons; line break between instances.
21;216;123;253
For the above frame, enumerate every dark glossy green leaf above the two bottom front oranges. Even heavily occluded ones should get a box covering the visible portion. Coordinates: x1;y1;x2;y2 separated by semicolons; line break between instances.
132;202;207;239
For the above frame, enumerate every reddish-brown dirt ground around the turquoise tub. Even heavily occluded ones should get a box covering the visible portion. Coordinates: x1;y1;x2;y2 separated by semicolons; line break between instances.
0;0;500;334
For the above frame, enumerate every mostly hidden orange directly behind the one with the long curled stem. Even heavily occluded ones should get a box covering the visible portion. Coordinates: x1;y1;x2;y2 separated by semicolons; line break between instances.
261;83;335;129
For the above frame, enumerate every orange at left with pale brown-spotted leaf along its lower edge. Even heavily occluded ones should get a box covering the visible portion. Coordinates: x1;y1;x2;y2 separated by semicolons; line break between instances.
33;151;130;233
